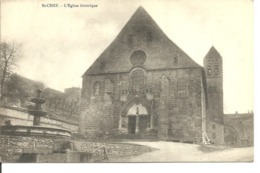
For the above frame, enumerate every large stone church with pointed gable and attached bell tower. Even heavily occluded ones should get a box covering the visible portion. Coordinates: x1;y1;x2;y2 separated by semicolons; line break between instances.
79;7;224;144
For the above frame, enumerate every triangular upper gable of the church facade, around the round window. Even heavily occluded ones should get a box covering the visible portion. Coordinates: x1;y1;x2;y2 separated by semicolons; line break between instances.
84;6;201;75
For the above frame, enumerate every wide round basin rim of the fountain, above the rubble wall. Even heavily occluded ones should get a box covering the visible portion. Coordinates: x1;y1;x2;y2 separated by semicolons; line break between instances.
1;125;71;138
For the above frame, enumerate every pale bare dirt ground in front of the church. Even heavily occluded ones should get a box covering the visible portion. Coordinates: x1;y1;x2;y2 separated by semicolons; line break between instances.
110;141;254;162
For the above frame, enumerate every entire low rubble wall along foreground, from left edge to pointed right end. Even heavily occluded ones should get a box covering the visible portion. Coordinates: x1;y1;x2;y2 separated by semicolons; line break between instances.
0;135;154;163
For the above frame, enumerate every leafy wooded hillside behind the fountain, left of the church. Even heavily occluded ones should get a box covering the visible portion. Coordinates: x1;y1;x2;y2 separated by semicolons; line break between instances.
3;74;81;121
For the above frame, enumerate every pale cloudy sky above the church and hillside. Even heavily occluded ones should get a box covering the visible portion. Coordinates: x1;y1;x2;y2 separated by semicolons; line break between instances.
1;0;254;113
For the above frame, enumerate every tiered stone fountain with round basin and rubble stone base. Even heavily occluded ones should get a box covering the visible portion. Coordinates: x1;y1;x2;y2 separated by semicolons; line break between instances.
0;90;92;163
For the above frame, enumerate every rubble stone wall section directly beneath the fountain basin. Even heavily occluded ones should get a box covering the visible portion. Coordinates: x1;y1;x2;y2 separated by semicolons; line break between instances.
0;135;54;162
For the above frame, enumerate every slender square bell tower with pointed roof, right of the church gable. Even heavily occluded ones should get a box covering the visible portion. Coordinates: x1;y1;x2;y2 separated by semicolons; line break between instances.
204;46;224;124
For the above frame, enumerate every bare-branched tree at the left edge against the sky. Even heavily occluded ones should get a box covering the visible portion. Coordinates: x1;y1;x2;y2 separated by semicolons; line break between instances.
0;42;21;99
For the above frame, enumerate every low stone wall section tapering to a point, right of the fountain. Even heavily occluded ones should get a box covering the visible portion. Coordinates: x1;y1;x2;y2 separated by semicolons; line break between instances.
73;141;155;161
